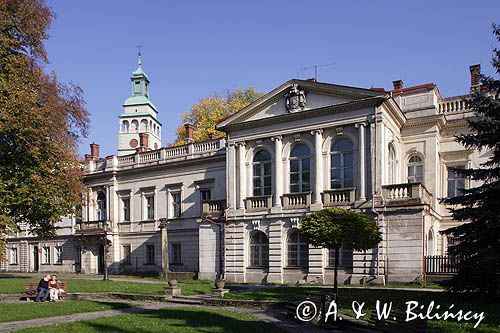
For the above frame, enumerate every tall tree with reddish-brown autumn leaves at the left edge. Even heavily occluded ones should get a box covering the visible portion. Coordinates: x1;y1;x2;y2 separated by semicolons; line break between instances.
0;0;89;254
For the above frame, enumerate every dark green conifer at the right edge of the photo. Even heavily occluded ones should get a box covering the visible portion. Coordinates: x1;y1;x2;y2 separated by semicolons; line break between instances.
444;24;500;294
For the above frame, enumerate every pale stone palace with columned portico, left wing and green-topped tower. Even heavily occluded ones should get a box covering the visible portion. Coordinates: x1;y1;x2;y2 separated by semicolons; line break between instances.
1;57;489;284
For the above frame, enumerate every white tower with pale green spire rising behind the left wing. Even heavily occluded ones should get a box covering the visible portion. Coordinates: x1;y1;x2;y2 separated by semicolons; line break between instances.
118;51;161;156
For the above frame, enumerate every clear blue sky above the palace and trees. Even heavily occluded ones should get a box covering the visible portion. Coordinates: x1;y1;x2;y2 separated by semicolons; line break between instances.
46;0;500;156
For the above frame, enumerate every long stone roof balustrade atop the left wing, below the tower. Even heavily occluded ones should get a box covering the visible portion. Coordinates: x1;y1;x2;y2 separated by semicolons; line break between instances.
84;138;226;173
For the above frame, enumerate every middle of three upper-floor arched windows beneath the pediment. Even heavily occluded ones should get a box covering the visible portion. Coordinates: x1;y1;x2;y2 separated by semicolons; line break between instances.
290;144;311;193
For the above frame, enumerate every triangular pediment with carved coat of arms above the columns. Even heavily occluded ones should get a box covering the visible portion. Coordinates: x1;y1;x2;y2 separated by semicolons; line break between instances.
217;79;386;130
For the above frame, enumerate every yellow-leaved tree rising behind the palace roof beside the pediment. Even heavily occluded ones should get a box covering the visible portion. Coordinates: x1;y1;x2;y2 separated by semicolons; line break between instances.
174;88;263;146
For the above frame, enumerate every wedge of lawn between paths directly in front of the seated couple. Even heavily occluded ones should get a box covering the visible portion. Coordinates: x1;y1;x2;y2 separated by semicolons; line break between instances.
0;301;130;323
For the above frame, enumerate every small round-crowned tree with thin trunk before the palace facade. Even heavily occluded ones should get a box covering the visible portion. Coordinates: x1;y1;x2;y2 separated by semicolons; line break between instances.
300;208;382;295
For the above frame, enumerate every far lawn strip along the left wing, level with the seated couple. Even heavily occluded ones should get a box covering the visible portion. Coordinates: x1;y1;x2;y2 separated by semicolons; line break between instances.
0;278;212;296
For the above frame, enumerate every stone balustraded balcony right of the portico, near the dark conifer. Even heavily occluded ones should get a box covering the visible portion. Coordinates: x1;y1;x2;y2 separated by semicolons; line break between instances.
382;183;434;206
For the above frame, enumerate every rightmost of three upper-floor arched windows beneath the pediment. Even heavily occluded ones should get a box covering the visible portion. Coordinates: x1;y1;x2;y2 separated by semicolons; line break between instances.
331;139;353;188
